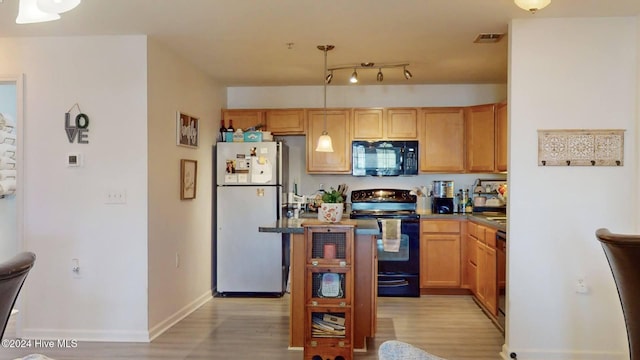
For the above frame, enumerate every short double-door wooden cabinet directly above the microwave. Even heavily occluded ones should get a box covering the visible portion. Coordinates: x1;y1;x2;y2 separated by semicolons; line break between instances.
352;108;418;140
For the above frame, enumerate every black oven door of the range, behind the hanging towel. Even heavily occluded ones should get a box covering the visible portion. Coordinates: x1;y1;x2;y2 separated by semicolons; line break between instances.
377;219;420;296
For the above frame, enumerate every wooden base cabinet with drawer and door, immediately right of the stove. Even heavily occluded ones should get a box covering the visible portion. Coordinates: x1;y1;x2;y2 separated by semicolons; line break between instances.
420;220;460;288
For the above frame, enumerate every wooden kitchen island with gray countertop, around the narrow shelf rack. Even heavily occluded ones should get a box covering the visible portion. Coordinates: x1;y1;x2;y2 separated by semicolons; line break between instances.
259;219;380;352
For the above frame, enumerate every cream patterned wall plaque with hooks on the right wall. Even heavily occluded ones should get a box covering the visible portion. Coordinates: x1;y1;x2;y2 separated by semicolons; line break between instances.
538;129;624;166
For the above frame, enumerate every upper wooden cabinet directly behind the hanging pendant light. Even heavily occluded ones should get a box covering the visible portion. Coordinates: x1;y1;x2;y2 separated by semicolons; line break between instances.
307;109;351;174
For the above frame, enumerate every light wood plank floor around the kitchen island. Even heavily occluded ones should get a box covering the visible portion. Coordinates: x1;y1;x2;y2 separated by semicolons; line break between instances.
0;295;504;360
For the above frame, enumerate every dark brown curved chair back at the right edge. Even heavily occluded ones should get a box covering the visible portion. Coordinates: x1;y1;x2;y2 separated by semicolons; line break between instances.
596;229;640;360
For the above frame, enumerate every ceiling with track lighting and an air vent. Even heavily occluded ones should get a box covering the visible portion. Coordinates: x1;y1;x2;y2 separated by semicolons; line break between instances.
0;0;640;86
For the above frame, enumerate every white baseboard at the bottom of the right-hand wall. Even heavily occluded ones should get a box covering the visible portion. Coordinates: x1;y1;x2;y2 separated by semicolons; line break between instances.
500;344;629;360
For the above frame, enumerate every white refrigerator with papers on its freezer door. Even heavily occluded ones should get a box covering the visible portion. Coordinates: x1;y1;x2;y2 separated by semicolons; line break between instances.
213;142;288;296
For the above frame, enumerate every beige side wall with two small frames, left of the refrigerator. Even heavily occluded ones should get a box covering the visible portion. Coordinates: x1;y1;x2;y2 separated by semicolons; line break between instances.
147;40;225;338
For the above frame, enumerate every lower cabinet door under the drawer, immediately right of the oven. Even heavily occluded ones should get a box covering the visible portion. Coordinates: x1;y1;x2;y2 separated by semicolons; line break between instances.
420;234;460;287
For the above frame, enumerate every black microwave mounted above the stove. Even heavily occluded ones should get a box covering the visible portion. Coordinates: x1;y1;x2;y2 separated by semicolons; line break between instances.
351;141;418;176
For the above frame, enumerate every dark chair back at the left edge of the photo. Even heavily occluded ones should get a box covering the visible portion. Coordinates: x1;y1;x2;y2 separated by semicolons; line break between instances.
0;252;36;339
